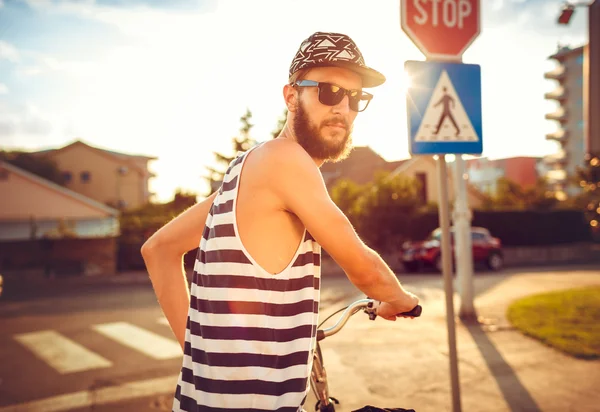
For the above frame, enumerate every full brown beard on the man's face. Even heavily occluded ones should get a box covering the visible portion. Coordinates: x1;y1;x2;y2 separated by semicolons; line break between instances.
292;103;352;162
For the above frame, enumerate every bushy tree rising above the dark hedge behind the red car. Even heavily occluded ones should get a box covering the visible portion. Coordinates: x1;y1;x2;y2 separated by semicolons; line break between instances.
482;177;559;211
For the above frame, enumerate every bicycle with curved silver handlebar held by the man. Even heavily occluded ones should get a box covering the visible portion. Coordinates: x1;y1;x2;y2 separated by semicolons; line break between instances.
310;298;423;412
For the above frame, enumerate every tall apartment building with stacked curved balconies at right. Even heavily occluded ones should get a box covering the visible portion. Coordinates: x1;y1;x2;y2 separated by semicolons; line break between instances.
544;46;586;198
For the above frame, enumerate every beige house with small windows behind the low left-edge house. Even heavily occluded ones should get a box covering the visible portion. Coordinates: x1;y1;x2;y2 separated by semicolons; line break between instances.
35;140;156;210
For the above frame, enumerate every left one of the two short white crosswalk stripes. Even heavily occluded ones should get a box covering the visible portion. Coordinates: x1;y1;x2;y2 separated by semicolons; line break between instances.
15;330;112;374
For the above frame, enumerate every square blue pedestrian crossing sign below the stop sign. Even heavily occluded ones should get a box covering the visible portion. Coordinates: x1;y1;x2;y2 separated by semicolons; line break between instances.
404;61;483;154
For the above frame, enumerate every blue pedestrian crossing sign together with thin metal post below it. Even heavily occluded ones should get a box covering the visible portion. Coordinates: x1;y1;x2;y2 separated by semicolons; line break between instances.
404;40;483;412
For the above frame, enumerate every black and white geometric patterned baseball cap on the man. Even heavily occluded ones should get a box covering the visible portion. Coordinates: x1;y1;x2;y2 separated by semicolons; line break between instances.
290;32;385;87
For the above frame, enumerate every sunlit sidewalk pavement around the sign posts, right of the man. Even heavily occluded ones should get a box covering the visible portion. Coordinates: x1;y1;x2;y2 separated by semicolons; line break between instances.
306;268;600;412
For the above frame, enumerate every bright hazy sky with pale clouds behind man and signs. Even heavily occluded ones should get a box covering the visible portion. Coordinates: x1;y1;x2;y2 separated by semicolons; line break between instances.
0;0;587;201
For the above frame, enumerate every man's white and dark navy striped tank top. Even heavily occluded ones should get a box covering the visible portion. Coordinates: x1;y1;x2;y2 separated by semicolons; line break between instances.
173;146;321;412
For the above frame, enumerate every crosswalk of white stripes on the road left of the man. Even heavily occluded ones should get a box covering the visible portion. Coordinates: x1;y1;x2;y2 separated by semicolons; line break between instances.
14;317;182;375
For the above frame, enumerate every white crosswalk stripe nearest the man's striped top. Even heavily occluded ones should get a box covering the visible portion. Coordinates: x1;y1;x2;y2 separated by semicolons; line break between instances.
92;322;183;359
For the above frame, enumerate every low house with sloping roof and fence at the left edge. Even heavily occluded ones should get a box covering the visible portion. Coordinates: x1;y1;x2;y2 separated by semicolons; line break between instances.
0;161;120;275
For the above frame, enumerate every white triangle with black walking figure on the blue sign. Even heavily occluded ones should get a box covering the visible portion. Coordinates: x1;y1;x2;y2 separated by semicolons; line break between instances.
415;70;479;142
